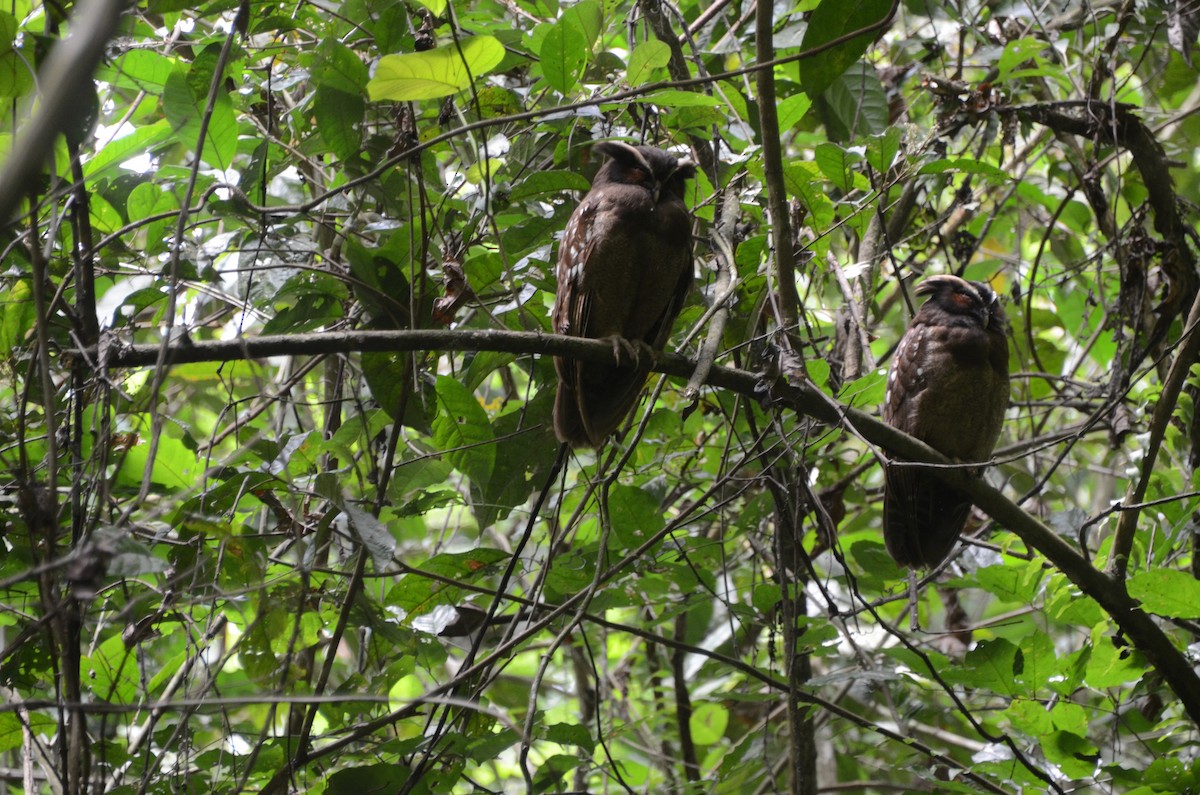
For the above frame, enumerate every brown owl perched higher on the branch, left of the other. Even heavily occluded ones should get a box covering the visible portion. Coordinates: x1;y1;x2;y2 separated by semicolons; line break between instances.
554;141;696;447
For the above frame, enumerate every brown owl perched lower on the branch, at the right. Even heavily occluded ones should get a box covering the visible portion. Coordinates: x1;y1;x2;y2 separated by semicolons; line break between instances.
883;276;1008;568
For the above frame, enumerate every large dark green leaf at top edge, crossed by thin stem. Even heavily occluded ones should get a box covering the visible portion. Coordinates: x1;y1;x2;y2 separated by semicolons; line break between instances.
800;0;892;97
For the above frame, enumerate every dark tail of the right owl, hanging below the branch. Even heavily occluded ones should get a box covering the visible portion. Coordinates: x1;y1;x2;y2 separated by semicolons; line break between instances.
883;466;971;568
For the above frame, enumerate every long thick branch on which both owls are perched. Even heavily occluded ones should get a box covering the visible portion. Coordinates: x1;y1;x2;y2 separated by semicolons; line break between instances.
77;330;1200;724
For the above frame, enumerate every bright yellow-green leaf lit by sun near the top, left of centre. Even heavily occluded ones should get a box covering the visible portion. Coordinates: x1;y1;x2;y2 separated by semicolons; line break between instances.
367;36;504;102
